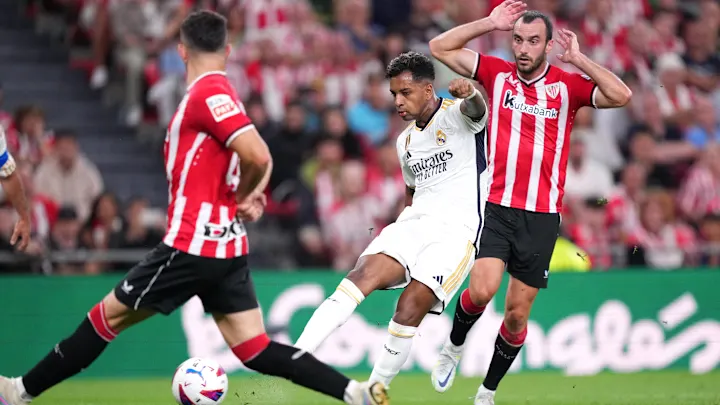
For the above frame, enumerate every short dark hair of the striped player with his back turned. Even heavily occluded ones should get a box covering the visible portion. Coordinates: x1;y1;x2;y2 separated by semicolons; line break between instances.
180;10;227;53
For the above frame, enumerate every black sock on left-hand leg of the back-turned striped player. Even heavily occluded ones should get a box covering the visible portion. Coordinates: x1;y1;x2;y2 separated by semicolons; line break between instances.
22;318;108;397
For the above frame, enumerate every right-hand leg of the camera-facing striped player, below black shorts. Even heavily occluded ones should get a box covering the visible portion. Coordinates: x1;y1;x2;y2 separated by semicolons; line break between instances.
475;277;538;405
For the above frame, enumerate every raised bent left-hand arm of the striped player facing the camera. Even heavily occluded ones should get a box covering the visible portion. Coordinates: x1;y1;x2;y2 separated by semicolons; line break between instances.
430;0;527;79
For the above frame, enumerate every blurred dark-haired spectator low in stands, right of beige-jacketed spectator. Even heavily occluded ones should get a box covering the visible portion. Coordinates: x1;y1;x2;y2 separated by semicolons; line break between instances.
80;192;124;274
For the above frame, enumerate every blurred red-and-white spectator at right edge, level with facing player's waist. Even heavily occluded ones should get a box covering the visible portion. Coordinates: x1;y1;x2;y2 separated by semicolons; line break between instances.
678;143;720;221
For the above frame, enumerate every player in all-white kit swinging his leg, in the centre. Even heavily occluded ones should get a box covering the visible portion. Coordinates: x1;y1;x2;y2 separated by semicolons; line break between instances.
295;52;486;386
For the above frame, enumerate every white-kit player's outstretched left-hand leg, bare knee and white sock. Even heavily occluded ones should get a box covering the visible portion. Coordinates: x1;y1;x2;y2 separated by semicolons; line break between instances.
295;253;405;353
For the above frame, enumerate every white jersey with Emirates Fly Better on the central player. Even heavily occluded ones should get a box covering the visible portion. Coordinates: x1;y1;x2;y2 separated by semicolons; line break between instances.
397;95;487;246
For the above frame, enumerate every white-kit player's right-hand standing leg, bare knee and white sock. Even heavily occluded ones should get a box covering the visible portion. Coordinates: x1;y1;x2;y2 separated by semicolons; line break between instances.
370;280;438;387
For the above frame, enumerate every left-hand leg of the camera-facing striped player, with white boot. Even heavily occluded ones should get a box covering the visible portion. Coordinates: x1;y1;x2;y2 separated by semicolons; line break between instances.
431;257;505;392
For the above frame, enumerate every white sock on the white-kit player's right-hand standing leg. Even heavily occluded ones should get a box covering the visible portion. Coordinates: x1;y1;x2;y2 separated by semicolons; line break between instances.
370;321;417;387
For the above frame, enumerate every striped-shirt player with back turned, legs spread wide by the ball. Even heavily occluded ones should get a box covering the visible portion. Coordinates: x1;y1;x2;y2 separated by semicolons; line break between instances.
0;11;389;405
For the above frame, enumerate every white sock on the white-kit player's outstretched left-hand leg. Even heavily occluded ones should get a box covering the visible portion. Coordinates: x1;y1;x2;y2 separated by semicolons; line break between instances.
295;279;365;353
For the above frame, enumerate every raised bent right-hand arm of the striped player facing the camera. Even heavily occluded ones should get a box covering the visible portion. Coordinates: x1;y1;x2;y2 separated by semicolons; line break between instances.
556;29;632;108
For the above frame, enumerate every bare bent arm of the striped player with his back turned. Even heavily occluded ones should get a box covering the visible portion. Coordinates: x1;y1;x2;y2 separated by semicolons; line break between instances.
230;128;272;201
